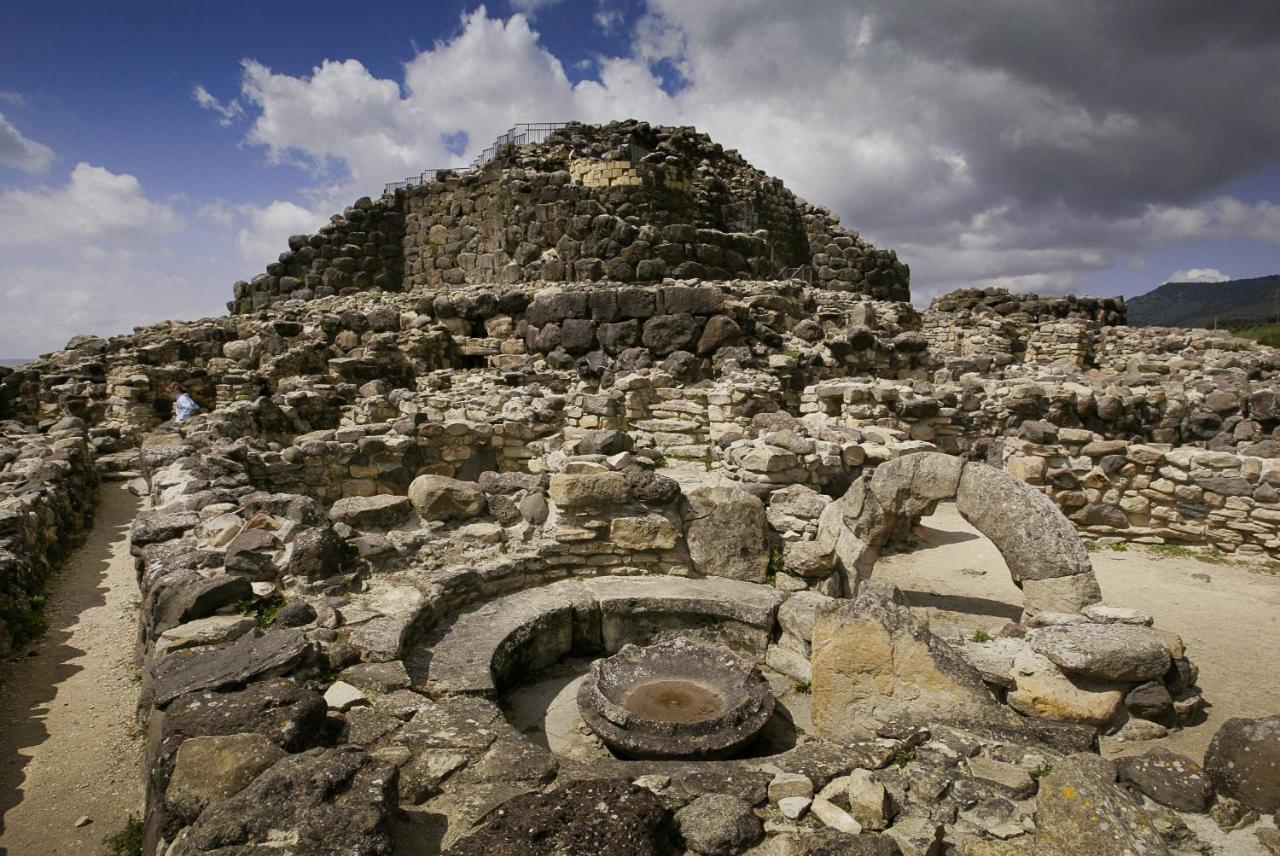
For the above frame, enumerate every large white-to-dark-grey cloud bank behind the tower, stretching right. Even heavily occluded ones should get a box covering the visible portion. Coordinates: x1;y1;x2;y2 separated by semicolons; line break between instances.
215;0;1280;307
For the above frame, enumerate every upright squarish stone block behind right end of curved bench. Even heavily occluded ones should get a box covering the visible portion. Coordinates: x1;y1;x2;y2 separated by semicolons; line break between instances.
681;487;769;582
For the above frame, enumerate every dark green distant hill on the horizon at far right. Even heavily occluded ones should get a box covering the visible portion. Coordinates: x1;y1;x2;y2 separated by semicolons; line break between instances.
1126;274;1280;329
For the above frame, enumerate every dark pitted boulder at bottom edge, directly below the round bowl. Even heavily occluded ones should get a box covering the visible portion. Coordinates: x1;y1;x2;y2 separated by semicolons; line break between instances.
445;779;680;856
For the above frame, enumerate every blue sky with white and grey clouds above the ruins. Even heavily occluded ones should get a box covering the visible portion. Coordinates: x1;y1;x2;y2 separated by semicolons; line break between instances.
0;0;1280;358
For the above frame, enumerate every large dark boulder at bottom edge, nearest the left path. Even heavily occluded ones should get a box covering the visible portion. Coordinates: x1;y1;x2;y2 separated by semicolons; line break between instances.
168;746;398;856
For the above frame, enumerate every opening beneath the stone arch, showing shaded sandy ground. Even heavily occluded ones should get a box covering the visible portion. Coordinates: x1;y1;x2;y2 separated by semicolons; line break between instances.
872;502;1023;641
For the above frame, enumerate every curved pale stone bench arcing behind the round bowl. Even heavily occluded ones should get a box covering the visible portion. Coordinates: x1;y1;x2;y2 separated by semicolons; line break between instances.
419;577;782;697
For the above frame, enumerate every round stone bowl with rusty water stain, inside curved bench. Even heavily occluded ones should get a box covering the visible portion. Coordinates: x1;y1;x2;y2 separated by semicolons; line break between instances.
577;640;774;760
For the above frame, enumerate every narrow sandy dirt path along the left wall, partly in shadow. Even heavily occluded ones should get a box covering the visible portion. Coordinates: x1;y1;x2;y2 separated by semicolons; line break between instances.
0;484;142;856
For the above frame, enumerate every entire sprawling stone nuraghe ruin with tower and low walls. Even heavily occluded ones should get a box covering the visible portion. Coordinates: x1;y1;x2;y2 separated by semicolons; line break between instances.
0;122;1280;856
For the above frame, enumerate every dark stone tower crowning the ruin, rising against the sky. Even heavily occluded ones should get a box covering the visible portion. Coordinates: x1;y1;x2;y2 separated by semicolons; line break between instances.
229;122;909;312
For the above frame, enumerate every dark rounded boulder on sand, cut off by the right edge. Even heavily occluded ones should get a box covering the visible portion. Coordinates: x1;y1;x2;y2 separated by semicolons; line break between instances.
1204;717;1280;811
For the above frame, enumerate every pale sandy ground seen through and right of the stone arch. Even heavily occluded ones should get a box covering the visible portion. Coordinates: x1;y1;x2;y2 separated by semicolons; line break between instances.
873;504;1280;760
